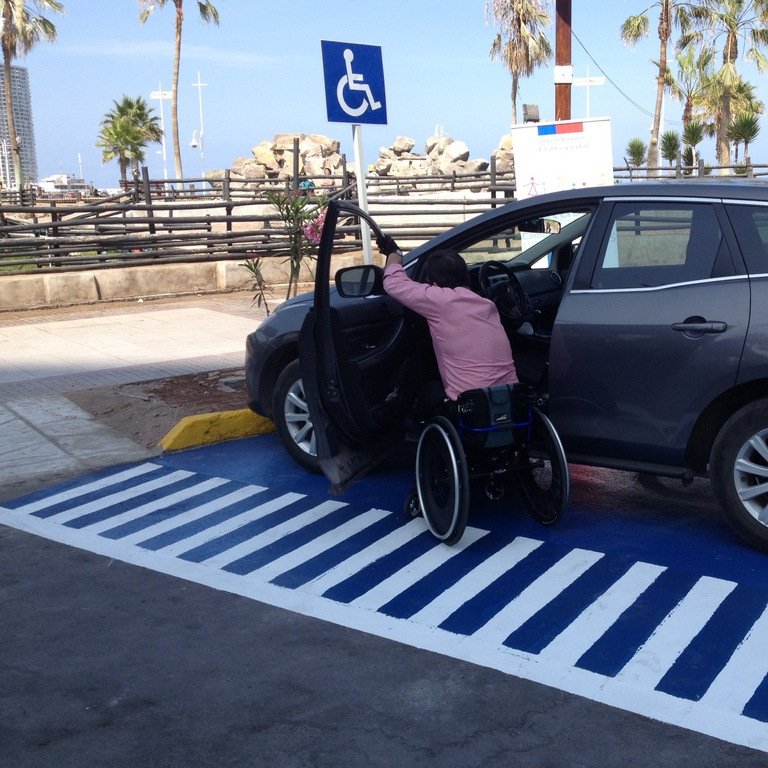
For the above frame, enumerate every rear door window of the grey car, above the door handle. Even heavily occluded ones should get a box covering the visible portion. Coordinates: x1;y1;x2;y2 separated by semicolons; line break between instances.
591;202;733;289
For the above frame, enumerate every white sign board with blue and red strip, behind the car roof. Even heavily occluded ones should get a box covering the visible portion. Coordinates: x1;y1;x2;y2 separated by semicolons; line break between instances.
510;117;614;200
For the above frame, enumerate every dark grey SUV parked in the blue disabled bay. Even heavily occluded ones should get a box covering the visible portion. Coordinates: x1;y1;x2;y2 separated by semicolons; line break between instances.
246;180;768;551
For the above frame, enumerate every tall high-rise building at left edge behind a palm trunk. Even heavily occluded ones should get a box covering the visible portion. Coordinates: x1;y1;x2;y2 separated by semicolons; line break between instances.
0;67;37;189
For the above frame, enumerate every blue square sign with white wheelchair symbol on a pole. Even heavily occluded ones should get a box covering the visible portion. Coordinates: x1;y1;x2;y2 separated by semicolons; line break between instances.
320;40;387;125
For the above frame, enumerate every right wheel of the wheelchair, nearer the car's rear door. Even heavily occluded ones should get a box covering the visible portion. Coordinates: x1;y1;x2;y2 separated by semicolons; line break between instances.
519;408;571;525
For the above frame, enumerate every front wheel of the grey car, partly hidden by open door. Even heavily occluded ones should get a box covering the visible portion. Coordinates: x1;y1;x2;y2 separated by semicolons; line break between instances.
272;360;320;473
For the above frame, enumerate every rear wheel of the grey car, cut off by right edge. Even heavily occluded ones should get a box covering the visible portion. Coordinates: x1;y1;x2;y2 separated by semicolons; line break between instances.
709;399;768;552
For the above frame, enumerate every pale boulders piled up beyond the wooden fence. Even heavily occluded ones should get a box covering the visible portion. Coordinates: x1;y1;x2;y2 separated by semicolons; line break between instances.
212;133;513;184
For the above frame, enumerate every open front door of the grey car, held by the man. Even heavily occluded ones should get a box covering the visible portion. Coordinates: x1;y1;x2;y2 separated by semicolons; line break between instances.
299;201;413;492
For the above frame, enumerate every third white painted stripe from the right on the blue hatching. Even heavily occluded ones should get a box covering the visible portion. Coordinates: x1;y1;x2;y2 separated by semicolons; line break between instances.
539;563;666;665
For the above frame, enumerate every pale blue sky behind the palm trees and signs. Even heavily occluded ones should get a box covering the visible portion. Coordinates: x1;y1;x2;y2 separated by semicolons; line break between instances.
24;0;768;188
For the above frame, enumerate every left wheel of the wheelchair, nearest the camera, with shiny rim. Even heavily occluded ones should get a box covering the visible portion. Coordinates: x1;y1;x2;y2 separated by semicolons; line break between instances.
416;416;469;544
